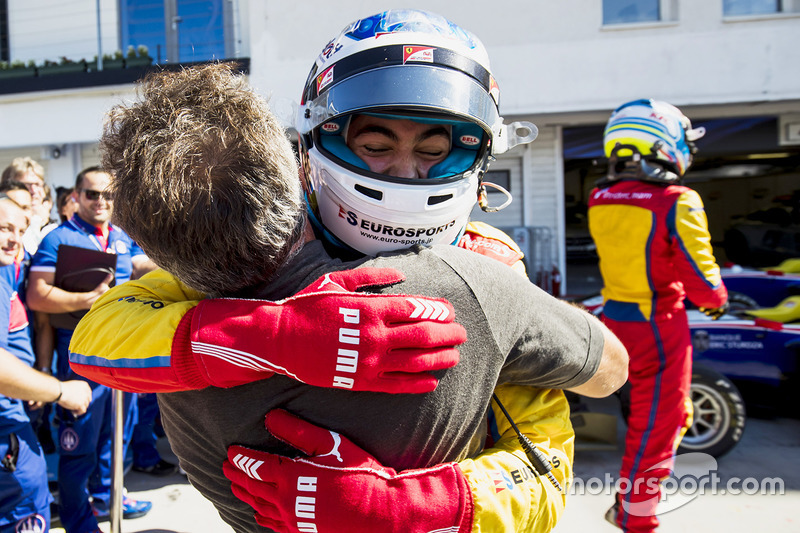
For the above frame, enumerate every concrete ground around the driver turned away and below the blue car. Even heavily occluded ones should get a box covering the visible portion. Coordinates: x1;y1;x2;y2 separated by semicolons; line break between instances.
554;402;800;533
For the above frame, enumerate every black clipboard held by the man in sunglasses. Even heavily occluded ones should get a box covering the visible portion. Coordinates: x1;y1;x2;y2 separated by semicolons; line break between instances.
50;244;117;329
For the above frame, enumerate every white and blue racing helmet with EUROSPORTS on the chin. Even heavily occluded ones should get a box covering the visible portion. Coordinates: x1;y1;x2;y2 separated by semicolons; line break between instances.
295;9;537;254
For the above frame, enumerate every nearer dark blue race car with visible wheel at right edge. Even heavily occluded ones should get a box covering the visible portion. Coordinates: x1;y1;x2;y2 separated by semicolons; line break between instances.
680;308;800;457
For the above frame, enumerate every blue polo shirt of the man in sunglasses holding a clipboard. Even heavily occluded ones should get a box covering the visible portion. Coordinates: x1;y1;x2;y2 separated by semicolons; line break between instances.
31;214;144;348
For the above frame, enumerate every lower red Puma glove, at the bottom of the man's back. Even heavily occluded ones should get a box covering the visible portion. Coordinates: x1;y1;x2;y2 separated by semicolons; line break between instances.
223;409;473;533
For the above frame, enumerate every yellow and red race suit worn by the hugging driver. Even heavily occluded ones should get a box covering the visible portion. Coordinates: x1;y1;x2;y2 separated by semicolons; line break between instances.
70;219;574;533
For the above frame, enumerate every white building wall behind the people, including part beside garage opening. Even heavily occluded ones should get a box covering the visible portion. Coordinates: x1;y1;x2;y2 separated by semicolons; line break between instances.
0;0;800;274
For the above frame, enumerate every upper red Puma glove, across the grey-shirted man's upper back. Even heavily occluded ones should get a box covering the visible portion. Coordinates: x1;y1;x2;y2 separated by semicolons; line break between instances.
173;268;466;393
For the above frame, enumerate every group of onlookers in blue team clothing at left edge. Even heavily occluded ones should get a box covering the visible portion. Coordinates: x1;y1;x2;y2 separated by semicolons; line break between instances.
0;157;178;533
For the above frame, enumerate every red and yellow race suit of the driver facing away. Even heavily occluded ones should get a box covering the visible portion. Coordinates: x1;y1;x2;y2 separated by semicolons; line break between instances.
589;181;727;532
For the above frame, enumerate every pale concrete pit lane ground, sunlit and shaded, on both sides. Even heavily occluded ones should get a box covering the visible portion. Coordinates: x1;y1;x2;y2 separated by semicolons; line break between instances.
51;400;800;533
